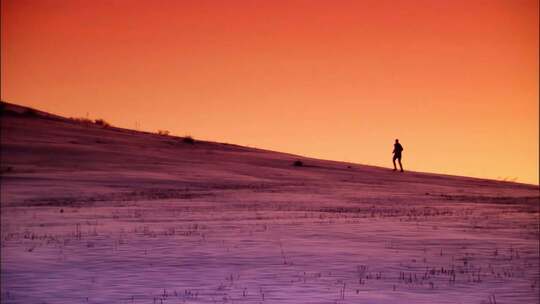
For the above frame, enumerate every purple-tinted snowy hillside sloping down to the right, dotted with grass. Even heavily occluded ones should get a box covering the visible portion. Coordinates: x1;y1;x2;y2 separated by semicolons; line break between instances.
1;105;540;304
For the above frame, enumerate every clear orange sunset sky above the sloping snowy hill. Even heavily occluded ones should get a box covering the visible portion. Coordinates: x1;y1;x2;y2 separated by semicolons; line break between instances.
1;0;539;184
